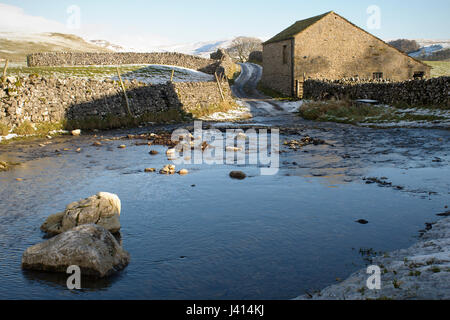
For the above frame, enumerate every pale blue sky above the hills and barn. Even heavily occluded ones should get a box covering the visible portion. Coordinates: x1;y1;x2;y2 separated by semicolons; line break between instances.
0;0;450;43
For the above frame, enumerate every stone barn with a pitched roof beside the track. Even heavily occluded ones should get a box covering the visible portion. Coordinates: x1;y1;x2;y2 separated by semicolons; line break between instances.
261;11;431;97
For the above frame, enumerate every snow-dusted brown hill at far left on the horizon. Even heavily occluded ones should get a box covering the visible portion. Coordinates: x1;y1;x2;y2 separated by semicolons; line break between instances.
0;32;112;64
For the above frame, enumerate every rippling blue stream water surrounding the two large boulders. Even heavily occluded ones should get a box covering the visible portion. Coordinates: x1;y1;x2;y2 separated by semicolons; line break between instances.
0;121;450;299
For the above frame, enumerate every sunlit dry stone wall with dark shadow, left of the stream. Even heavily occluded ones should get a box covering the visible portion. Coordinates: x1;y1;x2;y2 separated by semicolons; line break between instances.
0;76;233;127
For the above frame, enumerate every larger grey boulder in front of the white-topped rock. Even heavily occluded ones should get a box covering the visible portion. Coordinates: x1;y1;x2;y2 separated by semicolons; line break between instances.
22;224;130;278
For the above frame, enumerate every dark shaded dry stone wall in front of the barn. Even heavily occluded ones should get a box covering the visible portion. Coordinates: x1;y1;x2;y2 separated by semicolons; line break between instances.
303;77;450;106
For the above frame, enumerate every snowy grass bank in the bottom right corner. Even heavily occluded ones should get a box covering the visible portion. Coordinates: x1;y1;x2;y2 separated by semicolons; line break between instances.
296;218;450;300
